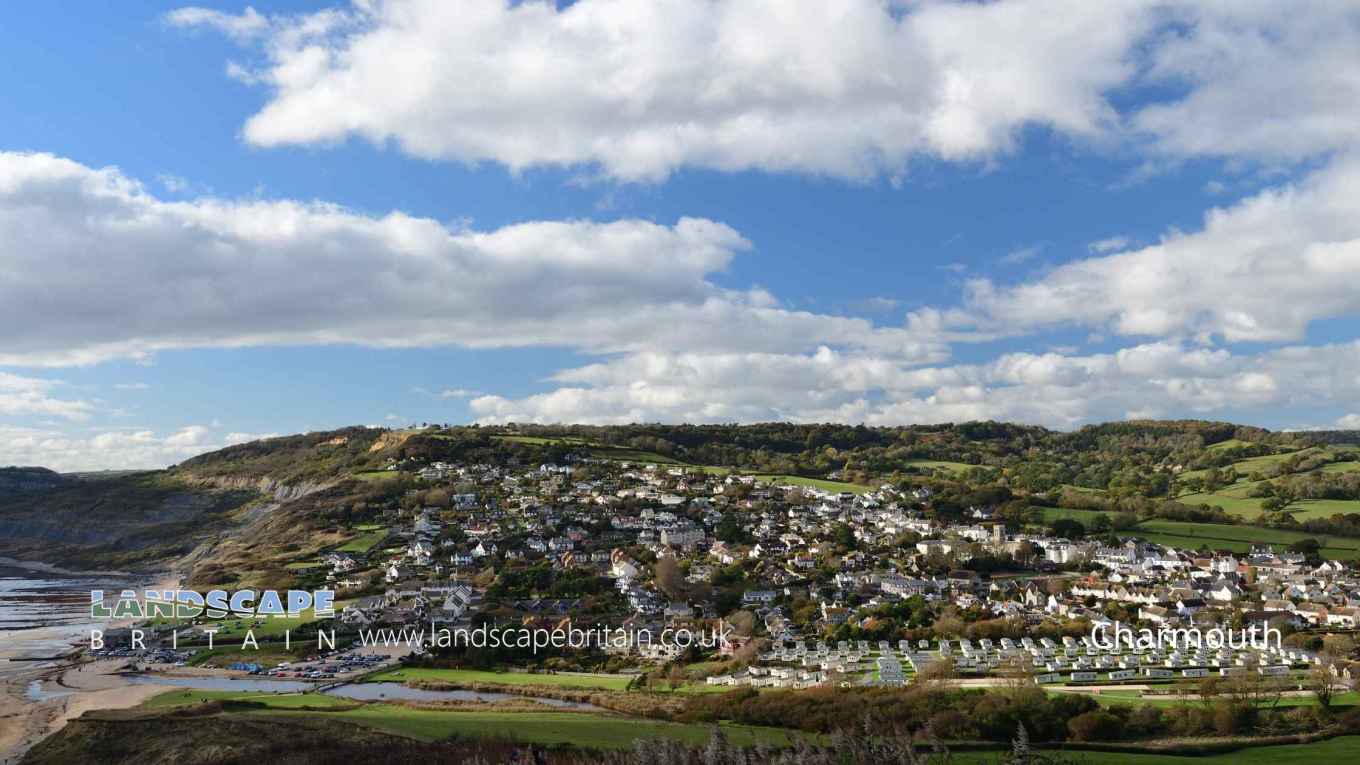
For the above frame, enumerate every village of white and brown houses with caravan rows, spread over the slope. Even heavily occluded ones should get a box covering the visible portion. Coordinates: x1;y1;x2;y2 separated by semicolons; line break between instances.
257;455;1360;689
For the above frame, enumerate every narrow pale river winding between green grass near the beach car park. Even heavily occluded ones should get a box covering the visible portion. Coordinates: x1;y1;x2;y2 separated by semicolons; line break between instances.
116;675;605;712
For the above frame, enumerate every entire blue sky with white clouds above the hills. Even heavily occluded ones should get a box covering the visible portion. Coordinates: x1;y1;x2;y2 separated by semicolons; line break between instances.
0;0;1360;470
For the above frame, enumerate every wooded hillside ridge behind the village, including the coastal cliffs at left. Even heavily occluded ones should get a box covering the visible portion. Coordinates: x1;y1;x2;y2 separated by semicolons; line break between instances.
0;421;1360;574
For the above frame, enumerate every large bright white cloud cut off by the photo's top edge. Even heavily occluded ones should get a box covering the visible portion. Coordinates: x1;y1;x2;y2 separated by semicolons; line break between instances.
169;0;1155;181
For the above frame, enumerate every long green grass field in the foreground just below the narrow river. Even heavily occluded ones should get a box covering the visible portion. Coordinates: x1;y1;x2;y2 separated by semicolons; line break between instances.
265;704;798;749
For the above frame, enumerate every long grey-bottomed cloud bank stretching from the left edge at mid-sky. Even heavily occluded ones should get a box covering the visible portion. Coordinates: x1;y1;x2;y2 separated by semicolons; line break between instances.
0;152;944;365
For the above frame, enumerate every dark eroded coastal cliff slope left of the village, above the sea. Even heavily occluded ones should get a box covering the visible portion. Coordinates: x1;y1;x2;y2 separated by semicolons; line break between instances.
0;427;394;581
